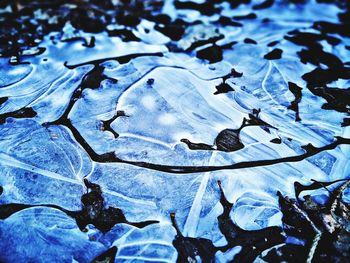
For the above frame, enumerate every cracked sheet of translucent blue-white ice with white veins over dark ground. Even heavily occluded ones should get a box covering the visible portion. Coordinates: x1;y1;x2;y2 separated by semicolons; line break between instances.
0;1;350;262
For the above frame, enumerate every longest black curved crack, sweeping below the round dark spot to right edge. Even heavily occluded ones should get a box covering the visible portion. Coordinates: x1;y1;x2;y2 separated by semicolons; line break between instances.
55;120;350;174
